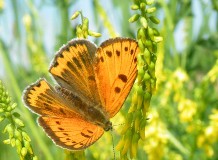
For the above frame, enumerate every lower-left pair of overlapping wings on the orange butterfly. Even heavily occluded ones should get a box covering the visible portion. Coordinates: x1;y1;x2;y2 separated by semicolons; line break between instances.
23;79;104;150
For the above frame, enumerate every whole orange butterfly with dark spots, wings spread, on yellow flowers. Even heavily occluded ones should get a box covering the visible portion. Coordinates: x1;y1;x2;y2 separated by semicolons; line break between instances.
23;37;139;150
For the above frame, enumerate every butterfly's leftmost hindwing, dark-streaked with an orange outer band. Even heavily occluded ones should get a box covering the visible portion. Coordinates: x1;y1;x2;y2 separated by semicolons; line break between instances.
23;79;76;117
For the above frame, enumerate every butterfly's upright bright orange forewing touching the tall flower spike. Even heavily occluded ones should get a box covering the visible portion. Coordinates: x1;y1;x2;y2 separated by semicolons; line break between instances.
95;38;139;117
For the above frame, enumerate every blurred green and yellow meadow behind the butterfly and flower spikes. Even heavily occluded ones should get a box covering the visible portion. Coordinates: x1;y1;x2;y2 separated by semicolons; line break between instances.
0;0;218;160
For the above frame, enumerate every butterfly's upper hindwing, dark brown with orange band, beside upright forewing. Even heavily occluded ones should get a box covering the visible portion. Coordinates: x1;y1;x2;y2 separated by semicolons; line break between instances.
49;39;100;104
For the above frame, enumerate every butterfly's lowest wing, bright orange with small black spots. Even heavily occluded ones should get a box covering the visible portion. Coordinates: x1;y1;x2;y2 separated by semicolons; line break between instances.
38;116;104;150
